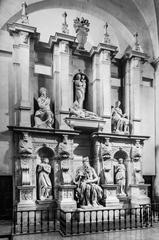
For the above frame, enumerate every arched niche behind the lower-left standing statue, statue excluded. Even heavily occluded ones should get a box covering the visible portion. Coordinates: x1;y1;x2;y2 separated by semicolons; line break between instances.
36;146;55;200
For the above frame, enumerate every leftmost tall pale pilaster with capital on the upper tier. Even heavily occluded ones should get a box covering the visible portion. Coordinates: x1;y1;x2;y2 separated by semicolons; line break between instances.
8;23;39;127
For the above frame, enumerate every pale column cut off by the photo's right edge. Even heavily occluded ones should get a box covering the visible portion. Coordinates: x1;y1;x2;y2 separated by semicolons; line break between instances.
154;58;159;201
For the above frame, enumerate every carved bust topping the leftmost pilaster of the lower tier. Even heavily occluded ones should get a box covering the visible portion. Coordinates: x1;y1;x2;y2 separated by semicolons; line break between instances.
19;132;33;154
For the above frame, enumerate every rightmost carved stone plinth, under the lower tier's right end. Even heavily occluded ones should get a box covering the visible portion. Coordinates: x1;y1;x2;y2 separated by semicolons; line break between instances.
129;184;150;207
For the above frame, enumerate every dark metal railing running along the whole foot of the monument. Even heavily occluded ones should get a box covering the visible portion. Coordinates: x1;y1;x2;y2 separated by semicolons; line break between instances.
13;204;159;236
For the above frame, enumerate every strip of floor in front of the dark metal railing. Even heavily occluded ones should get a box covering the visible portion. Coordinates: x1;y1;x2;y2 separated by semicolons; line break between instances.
14;224;159;240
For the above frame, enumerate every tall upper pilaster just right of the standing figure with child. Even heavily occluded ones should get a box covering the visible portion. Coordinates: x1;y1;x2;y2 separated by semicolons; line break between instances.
91;43;117;133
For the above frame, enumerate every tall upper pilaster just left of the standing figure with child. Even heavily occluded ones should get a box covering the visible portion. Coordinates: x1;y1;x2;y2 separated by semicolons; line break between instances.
51;33;74;129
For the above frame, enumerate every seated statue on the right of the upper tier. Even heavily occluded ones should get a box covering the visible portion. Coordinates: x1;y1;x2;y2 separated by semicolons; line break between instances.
112;101;130;134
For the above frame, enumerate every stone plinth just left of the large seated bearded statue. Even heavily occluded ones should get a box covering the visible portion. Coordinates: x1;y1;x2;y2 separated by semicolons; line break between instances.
58;184;77;211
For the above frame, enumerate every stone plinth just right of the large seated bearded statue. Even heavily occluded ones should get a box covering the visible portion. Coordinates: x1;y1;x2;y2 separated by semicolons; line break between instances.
102;184;120;209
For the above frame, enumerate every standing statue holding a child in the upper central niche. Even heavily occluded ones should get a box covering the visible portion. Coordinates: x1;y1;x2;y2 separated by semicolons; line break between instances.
74;73;86;109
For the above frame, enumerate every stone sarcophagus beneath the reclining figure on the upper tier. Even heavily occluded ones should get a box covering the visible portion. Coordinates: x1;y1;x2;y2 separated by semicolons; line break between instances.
65;117;106;132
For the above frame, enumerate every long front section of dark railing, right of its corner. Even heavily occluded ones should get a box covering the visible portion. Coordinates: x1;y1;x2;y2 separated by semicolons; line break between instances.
60;205;153;236
